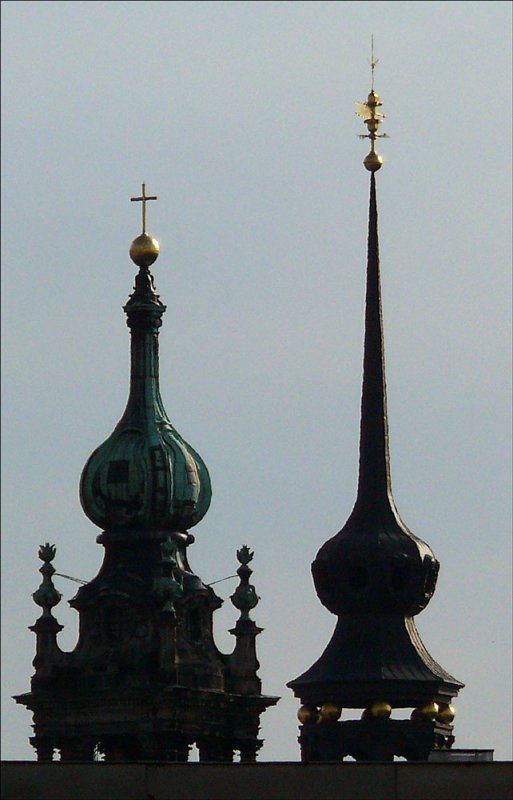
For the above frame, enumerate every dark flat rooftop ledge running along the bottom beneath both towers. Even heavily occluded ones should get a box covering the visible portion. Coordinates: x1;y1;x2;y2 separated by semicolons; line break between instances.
1;750;513;800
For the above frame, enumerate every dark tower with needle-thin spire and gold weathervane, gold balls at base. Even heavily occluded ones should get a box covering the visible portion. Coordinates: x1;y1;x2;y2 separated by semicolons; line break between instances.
288;64;463;762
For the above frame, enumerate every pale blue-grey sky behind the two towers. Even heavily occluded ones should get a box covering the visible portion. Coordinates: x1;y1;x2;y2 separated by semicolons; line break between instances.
2;1;511;760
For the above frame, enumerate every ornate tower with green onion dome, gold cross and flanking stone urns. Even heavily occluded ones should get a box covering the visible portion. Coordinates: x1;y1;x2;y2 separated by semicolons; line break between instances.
15;184;278;762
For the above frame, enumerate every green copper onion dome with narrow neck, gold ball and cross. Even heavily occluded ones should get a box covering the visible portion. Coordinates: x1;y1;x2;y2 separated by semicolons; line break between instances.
80;184;211;538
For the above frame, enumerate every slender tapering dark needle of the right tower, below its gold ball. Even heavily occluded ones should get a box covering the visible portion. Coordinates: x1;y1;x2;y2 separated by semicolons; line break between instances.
357;172;391;506
